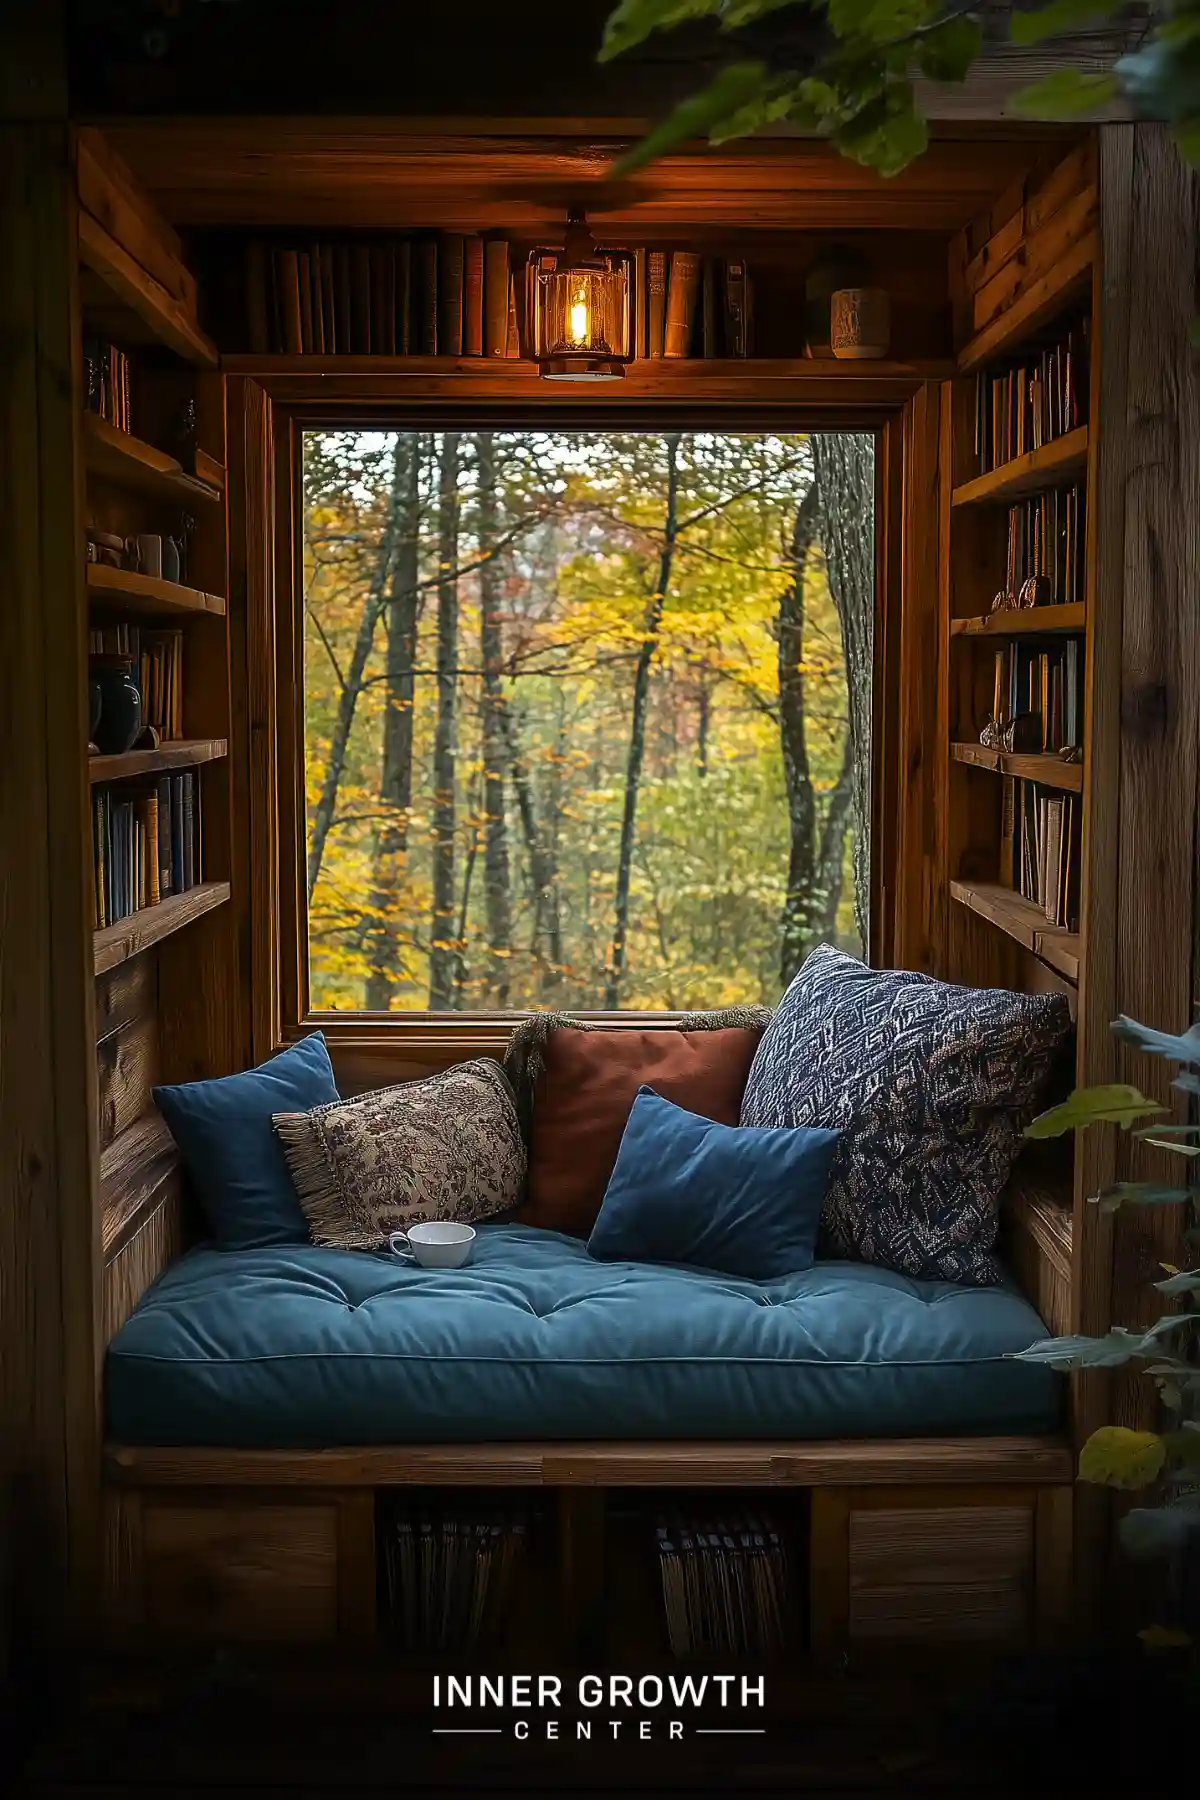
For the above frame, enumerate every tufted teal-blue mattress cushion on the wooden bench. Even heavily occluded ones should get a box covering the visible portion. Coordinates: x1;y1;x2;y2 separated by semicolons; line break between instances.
106;1224;1061;1449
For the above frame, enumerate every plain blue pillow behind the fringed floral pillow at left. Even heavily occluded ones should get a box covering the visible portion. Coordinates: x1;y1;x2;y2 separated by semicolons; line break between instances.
155;1031;340;1249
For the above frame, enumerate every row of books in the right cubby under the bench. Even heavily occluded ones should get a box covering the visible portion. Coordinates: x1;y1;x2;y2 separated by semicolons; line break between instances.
657;1512;795;1658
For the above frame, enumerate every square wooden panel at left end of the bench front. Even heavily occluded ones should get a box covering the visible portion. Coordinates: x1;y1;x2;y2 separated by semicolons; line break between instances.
142;1501;338;1642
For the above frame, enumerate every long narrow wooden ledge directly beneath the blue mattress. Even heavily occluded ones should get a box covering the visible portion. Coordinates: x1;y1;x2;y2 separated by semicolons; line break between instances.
106;1438;1072;1489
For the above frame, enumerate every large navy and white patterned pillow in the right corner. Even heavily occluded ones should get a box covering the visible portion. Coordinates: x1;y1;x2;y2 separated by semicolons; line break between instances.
741;945;1070;1285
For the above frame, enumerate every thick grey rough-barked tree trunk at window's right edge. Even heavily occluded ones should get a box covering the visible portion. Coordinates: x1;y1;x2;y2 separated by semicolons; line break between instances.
811;432;874;952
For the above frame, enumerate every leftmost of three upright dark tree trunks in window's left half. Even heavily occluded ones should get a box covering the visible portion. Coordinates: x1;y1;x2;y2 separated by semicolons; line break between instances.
367;432;421;1012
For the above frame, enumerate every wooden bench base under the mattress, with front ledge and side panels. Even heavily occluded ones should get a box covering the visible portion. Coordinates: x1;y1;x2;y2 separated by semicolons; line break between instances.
106;1438;1072;1658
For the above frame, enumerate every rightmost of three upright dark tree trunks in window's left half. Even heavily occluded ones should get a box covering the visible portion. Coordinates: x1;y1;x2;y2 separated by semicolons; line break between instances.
475;432;513;1008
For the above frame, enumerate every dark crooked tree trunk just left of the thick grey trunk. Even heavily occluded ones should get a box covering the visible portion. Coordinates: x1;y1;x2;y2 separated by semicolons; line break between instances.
777;481;819;988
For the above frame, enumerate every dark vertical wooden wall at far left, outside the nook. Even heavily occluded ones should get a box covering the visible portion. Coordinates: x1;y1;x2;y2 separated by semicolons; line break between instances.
0;105;101;1636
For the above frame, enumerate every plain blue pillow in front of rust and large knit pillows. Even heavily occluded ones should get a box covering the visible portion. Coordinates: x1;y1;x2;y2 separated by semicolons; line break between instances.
588;1087;838;1282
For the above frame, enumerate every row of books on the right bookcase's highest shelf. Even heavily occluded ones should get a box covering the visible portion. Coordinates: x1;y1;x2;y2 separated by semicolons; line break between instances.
975;320;1088;475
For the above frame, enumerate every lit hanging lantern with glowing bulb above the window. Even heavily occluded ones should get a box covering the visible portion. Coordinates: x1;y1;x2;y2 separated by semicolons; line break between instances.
529;212;631;382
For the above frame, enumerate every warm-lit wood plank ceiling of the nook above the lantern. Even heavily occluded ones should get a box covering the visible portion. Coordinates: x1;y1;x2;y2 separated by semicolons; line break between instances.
104;119;1045;236
